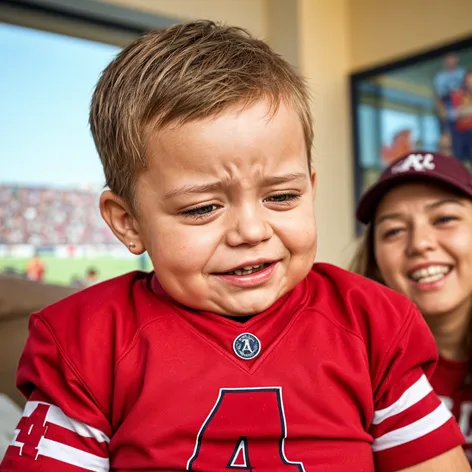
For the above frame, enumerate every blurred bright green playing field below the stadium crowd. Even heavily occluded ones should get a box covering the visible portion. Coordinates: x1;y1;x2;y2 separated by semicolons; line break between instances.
0;255;151;285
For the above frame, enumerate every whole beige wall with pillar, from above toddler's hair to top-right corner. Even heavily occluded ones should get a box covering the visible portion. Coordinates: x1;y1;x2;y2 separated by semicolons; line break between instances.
97;0;472;266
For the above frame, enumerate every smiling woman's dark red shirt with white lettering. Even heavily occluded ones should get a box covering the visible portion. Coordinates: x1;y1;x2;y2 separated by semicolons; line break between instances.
431;357;472;464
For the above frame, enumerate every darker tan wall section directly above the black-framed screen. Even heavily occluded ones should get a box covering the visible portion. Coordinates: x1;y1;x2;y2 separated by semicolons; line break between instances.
349;0;472;69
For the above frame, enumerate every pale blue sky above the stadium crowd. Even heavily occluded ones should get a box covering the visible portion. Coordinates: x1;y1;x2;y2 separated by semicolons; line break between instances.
0;23;119;187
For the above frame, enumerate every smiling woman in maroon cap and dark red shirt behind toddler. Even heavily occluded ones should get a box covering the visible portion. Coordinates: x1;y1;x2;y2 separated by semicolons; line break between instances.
352;152;472;462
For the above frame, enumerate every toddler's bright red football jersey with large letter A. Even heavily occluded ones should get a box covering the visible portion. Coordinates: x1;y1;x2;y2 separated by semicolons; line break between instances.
0;264;463;472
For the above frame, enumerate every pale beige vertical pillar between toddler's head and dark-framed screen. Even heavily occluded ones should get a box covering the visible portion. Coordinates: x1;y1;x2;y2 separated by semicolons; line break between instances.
299;0;354;265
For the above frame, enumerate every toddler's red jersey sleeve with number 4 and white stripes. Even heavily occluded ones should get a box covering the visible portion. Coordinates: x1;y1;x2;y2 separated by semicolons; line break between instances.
0;314;112;472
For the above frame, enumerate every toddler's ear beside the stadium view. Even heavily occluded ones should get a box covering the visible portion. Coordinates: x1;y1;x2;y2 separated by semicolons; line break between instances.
100;190;145;255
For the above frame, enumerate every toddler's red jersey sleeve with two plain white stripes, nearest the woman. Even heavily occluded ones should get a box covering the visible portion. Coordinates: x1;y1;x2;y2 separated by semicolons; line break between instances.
370;305;464;472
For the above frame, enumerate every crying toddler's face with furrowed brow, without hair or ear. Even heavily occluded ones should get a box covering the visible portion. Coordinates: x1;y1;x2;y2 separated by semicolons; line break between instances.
135;101;317;316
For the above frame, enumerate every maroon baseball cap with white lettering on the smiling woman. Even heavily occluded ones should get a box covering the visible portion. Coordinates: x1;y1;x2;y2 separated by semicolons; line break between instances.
356;151;472;224
